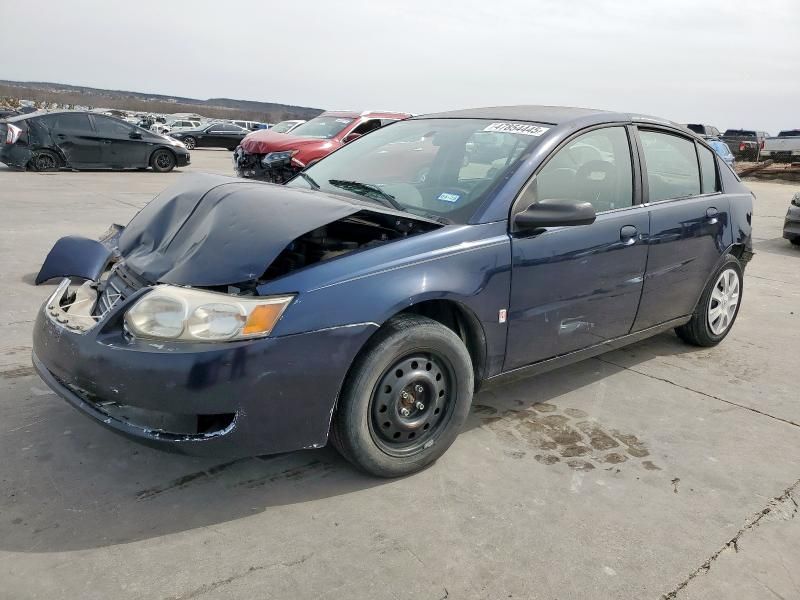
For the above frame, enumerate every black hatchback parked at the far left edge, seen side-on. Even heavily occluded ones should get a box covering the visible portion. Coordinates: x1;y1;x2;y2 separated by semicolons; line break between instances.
0;111;189;173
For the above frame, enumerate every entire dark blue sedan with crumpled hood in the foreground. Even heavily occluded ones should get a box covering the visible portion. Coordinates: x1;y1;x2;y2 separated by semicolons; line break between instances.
33;106;753;477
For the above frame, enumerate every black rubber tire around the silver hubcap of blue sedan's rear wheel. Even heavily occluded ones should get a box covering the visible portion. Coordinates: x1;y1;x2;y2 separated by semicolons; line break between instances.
675;254;744;347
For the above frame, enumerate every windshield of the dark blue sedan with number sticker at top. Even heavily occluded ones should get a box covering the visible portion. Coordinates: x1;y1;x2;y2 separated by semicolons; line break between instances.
287;119;547;223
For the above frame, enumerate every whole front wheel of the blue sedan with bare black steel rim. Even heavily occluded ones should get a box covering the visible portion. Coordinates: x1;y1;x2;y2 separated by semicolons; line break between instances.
331;315;474;477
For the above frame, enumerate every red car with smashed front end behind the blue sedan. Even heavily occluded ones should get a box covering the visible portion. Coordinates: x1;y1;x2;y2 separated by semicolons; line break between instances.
233;111;411;183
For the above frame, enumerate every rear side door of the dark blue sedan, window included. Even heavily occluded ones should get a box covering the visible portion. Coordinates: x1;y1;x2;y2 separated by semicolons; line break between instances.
633;128;731;331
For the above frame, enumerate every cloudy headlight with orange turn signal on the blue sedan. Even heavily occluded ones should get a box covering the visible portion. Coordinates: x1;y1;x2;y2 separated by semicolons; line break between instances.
125;285;294;342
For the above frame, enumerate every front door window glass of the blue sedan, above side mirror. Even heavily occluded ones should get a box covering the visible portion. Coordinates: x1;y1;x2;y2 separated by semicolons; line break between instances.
534;127;633;212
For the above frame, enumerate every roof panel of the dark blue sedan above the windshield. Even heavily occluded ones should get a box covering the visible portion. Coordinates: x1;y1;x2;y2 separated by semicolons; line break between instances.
414;105;678;127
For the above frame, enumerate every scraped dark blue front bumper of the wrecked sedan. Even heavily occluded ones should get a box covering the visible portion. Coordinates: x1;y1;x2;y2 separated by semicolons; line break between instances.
33;279;375;457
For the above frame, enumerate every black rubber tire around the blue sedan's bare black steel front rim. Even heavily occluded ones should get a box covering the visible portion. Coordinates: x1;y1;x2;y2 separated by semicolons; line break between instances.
331;314;474;477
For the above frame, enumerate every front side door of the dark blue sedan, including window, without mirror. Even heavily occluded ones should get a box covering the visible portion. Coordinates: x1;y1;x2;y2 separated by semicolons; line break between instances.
504;126;649;370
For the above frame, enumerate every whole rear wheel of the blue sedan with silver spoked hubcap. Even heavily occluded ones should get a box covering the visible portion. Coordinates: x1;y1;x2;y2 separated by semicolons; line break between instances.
675;255;744;347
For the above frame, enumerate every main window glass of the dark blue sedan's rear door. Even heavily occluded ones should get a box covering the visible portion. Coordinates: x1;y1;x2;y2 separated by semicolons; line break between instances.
639;131;700;202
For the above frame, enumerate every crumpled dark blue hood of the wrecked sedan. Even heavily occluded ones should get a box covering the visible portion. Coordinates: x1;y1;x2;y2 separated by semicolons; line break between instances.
119;174;363;286
